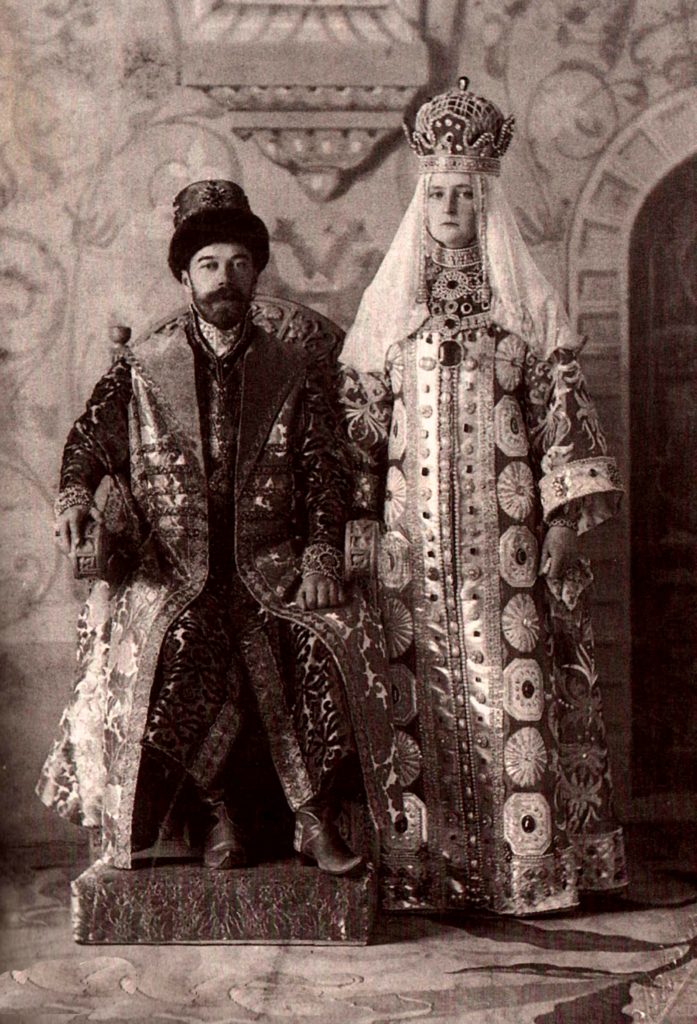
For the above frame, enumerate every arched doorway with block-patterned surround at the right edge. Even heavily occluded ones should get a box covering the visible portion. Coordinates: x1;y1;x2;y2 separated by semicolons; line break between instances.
568;86;697;820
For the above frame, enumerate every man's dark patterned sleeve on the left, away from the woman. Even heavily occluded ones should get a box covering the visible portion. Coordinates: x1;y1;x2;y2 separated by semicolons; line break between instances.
58;357;132;507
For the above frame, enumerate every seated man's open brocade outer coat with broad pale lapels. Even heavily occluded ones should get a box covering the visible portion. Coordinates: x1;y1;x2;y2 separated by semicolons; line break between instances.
38;314;401;867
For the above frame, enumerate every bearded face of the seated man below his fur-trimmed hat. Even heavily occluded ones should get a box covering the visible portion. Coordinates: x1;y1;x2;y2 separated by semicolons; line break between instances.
181;242;257;331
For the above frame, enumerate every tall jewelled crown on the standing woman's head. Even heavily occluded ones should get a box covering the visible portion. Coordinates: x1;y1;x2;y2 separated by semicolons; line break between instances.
404;78;515;174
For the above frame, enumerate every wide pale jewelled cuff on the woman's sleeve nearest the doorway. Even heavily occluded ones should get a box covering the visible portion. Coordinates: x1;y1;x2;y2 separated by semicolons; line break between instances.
539;457;622;534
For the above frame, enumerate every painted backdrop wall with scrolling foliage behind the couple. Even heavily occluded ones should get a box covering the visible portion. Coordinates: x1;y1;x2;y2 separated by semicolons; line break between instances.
0;0;697;853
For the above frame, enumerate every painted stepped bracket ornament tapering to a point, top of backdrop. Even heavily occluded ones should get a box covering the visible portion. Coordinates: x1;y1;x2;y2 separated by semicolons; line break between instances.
180;0;429;201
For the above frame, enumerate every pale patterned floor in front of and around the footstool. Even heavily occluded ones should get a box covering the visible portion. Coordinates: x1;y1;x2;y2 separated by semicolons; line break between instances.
0;847;697;1024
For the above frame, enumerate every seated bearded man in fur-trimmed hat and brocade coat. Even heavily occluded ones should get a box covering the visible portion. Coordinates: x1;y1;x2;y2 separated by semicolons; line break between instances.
38;180;401;874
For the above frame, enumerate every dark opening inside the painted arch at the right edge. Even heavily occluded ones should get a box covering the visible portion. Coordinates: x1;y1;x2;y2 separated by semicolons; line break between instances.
629;158;697;797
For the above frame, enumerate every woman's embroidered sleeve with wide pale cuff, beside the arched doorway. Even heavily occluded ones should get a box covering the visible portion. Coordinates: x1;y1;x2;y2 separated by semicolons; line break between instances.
524;348;622;534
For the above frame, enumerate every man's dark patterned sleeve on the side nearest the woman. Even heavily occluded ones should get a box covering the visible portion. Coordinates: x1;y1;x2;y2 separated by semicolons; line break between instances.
295;362;350;561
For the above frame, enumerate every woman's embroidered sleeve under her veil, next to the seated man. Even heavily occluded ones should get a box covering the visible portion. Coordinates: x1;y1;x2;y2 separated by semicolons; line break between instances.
339;367;392;518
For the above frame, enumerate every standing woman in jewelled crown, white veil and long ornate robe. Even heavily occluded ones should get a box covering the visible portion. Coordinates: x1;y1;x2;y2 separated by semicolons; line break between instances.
341;79;625;914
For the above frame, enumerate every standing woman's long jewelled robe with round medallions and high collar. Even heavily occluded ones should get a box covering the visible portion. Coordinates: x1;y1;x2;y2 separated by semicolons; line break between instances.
343;251;625;913
